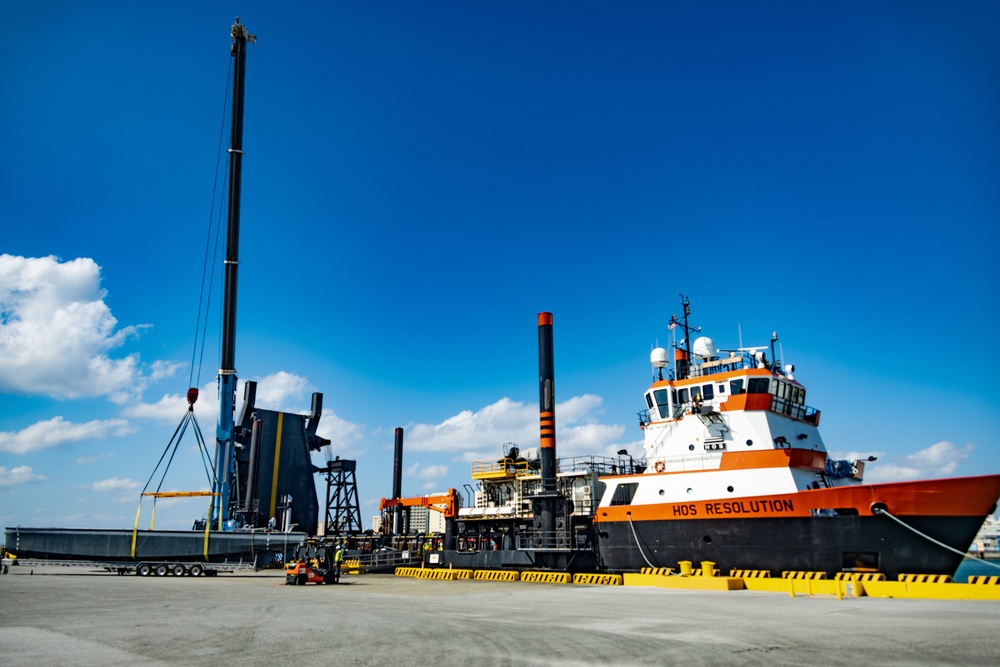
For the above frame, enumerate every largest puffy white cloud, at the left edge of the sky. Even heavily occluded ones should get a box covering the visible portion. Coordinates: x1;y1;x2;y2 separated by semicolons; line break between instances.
0;254;154;403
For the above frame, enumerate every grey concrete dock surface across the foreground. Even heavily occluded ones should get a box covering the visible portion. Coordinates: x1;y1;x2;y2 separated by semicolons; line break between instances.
0;566;1000;667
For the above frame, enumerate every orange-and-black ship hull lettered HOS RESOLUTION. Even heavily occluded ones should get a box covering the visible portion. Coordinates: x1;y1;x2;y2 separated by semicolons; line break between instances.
595;474;1000;578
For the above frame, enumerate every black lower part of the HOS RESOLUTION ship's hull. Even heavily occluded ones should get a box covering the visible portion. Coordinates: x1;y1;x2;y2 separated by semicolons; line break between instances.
598;516;982;579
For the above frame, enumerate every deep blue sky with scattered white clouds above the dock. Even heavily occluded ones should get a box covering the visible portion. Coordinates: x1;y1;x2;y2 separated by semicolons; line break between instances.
0;0;1000;527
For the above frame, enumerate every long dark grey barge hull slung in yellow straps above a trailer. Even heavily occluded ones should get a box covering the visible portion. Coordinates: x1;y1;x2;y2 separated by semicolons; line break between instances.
5;526;308;566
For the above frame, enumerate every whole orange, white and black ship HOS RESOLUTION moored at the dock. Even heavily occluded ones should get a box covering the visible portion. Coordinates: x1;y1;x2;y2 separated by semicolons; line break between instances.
396;298;1000;578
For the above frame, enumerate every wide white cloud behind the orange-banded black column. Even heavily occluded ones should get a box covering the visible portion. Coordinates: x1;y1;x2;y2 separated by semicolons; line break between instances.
406;394;625;461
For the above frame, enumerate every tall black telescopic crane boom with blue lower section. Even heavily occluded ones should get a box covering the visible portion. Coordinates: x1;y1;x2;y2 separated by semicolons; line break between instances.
212;17;256;530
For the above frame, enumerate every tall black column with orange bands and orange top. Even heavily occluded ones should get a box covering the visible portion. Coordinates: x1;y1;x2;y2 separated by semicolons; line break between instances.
538;313;557;546
